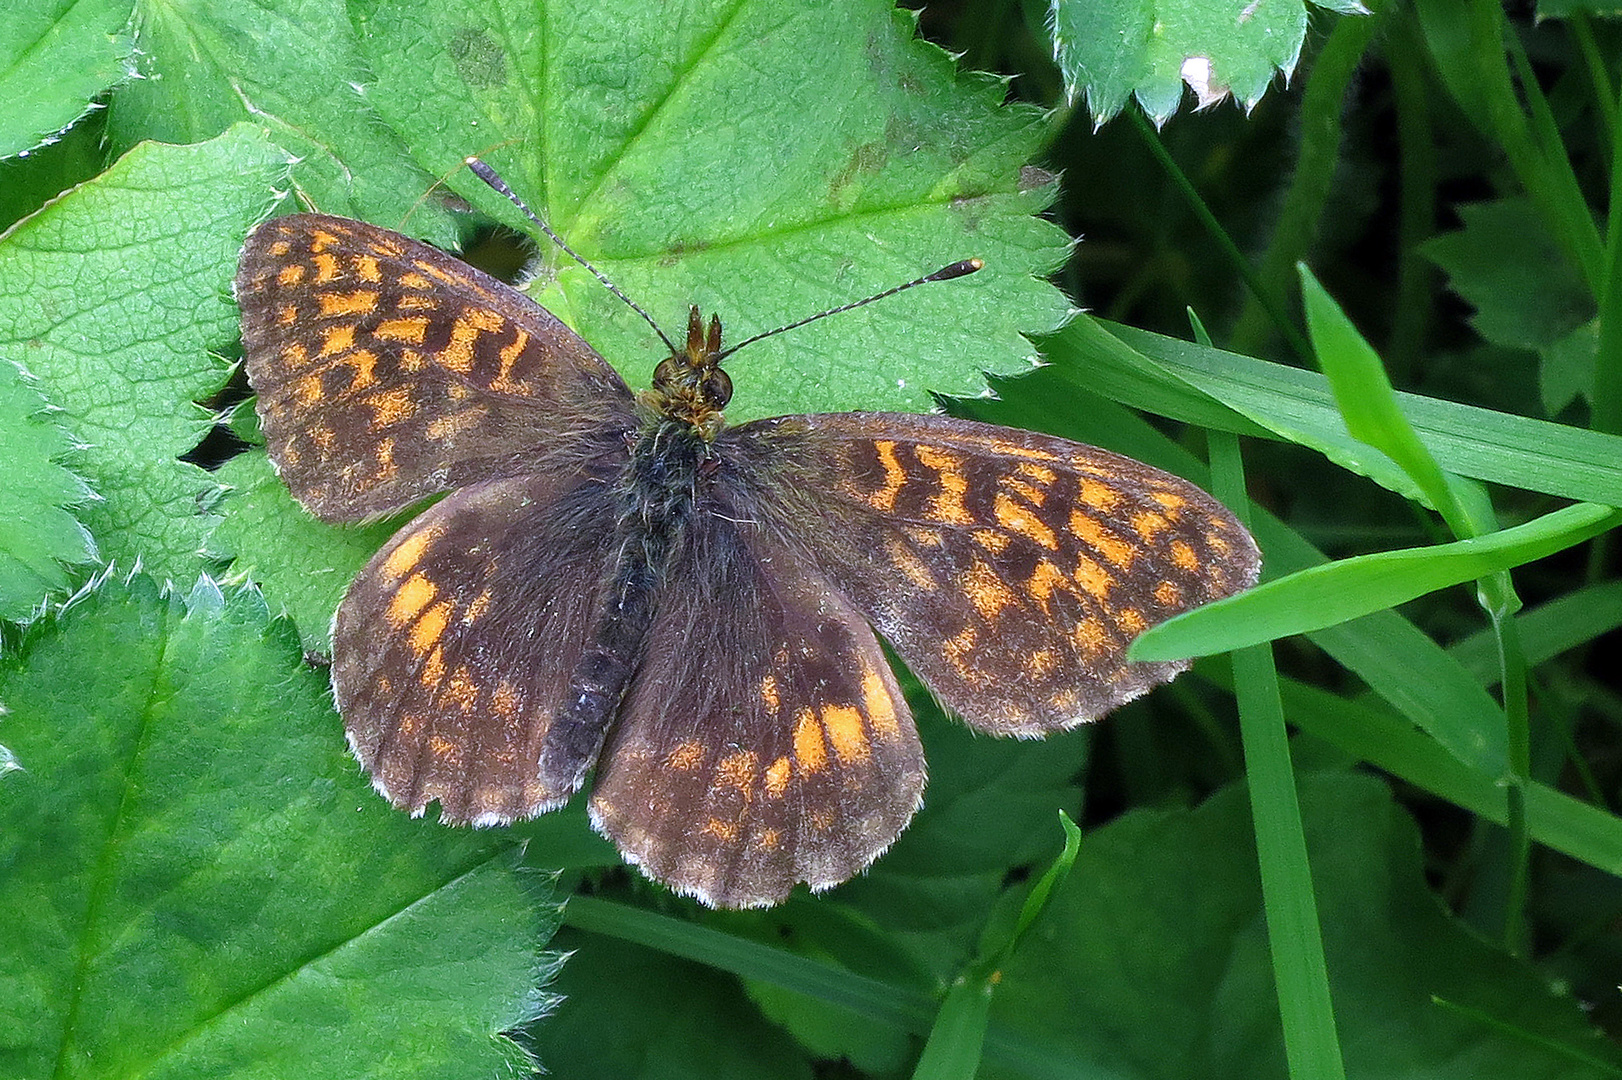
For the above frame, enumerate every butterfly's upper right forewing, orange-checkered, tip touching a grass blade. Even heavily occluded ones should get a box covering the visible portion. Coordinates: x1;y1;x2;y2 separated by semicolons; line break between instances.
717;414;1260;736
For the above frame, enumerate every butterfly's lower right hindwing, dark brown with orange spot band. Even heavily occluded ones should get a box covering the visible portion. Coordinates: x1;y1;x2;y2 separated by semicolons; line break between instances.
590;518;925;908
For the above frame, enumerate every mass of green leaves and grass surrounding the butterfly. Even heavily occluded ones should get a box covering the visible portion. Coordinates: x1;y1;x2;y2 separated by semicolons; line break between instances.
0;0;1622;1080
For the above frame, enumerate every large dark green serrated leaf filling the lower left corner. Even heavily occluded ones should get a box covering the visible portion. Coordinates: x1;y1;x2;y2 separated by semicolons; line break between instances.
0;567;556;1080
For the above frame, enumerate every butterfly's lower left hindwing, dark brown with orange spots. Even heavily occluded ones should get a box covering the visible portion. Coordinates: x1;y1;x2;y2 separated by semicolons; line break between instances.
333;462;615;825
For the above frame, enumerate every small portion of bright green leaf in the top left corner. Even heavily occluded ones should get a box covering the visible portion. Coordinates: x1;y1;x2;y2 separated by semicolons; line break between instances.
0;0;135;159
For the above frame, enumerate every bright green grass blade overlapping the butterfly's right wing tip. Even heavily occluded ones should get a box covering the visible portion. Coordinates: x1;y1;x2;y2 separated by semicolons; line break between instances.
1129;503;1622;660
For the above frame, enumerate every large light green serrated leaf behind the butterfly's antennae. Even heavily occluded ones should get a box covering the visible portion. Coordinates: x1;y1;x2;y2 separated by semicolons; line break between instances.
357;0;1069;420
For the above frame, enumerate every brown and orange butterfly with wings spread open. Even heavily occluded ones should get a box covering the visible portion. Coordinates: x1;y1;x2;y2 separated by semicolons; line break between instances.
235;195;1260;908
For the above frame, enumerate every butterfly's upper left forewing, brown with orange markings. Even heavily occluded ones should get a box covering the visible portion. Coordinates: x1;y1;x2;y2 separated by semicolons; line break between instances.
235;214;636;521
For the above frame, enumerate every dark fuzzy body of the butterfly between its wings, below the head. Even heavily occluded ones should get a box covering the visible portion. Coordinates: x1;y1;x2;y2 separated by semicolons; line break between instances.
540;418;706;791
